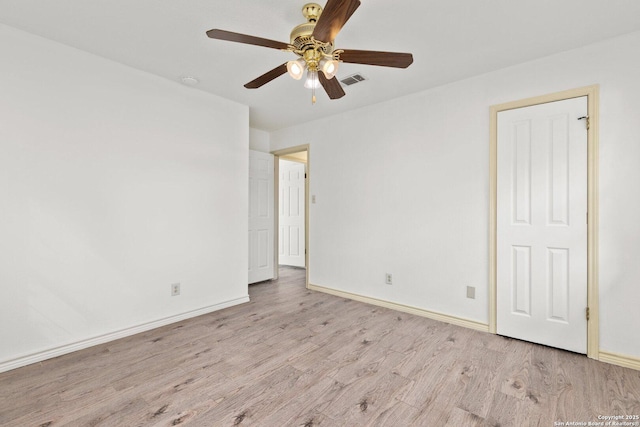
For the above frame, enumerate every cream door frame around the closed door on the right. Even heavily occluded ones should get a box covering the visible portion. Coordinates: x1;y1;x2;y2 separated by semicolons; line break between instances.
489;85;600;359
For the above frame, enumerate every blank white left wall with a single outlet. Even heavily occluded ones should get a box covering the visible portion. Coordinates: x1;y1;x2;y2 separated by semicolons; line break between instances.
0;25;249;370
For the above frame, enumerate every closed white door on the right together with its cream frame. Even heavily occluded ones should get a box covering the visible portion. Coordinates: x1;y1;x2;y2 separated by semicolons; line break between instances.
489;86;599;359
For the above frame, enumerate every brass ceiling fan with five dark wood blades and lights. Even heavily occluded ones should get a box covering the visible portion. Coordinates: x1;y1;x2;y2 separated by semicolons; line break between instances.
207;0;413;103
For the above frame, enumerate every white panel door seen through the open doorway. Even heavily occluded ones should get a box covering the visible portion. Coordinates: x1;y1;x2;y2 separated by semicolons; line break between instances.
278;159;306;267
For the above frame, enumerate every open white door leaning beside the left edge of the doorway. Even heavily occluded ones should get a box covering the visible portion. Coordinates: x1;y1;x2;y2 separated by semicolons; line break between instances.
249;150;275;283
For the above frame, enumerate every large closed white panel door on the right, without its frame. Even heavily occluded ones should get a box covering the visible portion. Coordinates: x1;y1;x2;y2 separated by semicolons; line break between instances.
496;96;587;353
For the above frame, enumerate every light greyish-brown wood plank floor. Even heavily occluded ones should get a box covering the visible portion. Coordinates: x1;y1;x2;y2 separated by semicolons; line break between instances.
0;268;640;427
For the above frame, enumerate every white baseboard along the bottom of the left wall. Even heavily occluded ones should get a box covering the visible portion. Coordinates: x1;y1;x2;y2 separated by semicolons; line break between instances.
0;295;249;372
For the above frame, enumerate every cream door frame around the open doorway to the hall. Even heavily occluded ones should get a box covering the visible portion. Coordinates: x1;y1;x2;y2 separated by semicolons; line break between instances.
271;144;311;289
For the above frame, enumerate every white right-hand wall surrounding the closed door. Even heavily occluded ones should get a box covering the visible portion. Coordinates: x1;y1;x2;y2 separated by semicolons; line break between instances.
271;29;640;357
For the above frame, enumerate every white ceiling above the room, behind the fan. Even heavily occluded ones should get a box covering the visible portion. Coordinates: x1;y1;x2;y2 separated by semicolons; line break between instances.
0;0;640;130
